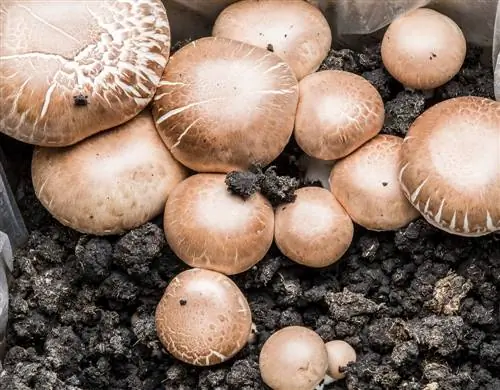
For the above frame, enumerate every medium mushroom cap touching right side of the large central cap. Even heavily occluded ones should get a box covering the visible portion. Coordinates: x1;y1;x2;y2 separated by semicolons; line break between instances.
294;70;385;160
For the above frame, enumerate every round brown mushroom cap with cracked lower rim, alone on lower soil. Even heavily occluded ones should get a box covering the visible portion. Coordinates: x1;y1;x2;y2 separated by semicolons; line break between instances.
155;268;252;366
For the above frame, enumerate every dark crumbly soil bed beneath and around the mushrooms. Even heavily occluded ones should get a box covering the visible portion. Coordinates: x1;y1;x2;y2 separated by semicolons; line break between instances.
0;40;500;390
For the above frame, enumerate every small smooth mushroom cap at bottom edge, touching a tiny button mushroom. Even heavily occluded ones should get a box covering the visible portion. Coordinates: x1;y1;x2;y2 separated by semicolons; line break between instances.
259;326;328;390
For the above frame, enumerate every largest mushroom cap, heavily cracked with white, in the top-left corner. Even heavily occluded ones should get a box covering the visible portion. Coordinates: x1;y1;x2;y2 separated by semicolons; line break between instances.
0;0;170;146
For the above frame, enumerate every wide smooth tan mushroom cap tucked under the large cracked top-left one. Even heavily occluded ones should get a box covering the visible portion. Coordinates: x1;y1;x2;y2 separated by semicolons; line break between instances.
32;110;188;235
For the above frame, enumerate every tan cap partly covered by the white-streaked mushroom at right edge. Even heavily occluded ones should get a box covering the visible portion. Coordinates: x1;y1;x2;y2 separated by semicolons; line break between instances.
330;134;419;230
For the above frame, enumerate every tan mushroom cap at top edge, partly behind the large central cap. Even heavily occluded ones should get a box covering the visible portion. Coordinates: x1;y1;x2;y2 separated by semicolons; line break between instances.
212;0;332;80
